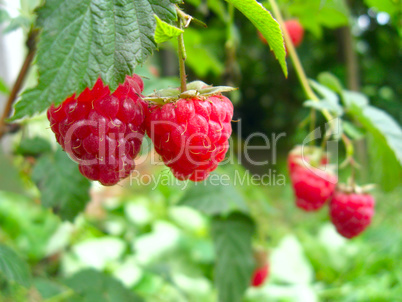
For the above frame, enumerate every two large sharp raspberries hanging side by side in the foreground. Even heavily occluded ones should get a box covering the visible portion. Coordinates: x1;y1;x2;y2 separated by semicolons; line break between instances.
47;75;233;186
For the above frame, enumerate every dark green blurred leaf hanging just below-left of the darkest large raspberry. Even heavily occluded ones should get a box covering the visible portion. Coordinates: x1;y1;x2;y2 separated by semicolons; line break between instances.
32;149;90;221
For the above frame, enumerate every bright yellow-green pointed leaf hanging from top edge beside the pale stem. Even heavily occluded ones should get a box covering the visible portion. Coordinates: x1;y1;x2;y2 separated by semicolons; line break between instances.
226;0;288;77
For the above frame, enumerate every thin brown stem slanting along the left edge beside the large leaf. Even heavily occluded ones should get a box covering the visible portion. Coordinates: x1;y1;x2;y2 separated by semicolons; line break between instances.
0;30;38;139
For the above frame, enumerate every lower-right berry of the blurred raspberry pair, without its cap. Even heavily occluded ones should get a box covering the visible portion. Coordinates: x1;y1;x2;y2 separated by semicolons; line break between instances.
329;191;375;238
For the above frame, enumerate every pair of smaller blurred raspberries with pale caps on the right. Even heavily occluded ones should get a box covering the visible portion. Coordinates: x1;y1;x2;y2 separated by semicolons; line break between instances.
288;147;375;238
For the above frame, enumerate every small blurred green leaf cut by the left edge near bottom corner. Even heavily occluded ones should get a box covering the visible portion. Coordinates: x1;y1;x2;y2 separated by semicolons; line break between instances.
0;244;31;287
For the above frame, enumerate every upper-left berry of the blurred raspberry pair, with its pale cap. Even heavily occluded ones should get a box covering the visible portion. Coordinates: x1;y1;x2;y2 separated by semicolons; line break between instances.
288;147;338;211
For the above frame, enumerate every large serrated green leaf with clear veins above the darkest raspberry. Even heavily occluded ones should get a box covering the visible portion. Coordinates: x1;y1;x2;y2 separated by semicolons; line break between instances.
12;0;177;120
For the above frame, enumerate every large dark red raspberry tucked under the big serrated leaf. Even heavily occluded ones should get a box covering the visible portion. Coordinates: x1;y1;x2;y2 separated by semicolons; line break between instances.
47;75;147;186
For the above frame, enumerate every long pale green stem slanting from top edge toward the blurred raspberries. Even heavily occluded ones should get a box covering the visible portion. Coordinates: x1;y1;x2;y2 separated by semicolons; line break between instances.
269;0;354;157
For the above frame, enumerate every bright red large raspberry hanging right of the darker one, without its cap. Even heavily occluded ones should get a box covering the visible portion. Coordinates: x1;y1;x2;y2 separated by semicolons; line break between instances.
146;94;233;181
